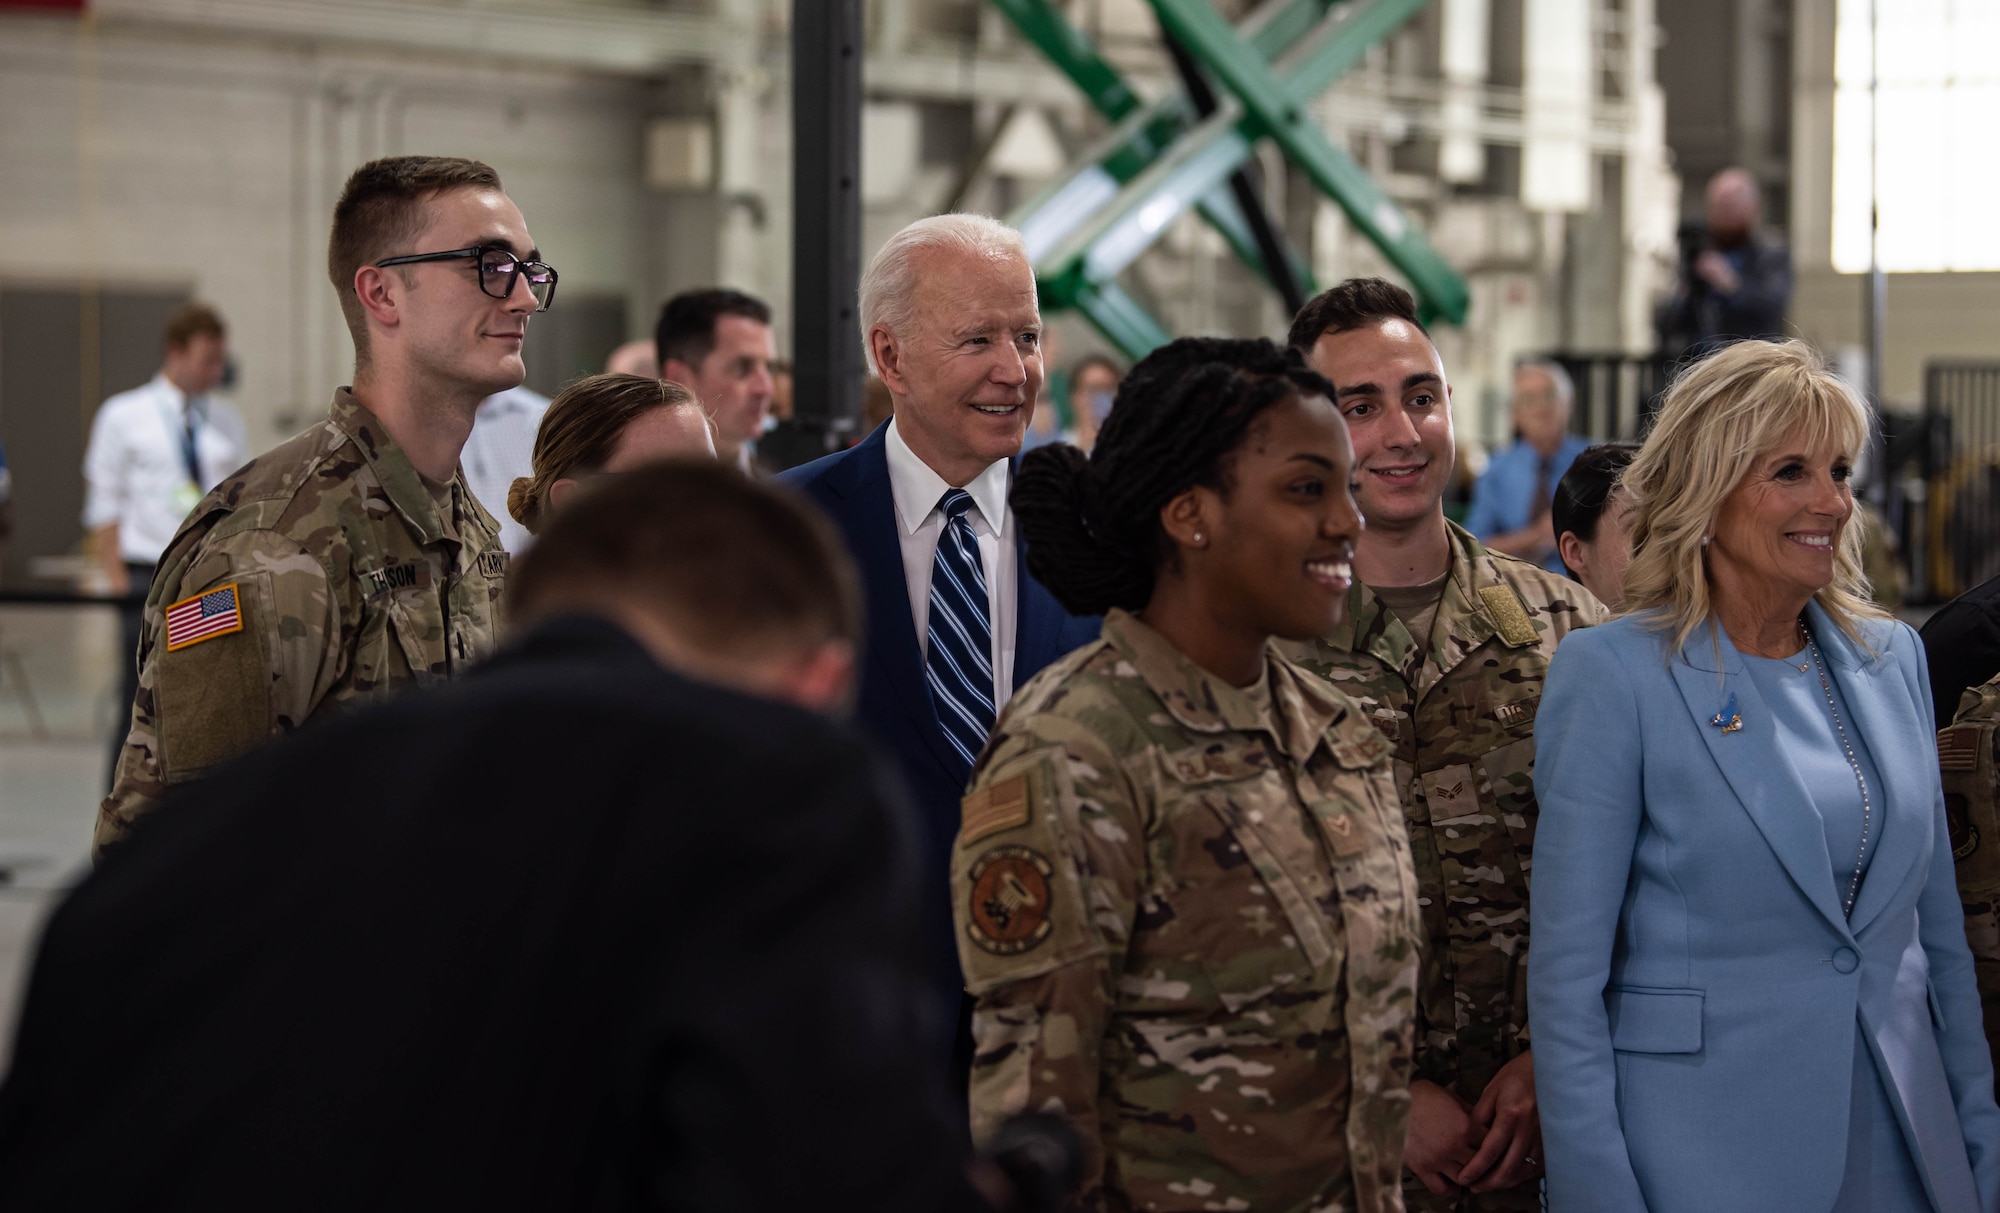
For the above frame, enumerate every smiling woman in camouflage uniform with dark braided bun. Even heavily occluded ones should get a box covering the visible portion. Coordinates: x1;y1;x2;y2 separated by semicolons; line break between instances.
968;338;1422;1213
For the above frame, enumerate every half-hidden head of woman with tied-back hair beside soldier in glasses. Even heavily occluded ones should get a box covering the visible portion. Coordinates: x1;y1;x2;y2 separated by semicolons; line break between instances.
506;374;716;534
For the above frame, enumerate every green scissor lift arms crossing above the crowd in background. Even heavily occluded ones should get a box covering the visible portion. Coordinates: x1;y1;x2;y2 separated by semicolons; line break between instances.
992;0;1466;358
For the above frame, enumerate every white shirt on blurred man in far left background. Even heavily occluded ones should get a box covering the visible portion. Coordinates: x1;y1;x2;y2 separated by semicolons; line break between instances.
84;374;248;564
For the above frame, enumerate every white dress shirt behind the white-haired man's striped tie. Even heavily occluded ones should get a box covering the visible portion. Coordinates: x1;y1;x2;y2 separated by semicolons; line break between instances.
884;418;1016;715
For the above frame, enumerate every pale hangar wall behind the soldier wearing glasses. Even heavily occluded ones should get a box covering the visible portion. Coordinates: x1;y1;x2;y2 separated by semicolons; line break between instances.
0;16;674;448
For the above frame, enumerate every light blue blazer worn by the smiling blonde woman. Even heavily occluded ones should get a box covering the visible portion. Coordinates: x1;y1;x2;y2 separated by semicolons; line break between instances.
1528;604;2000;1213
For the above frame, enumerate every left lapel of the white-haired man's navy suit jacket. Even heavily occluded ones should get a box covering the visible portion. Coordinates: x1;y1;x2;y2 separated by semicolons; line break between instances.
832;426;964;784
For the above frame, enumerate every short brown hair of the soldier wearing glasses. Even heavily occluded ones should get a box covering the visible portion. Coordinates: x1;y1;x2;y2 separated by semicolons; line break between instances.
326;156;502;364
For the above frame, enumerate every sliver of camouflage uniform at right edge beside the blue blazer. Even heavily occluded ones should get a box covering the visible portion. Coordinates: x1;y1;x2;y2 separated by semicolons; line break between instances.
1938;679;2000;1096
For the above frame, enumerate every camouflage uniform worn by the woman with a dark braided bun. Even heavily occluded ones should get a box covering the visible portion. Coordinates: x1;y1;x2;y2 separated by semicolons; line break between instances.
952;611;1420;1213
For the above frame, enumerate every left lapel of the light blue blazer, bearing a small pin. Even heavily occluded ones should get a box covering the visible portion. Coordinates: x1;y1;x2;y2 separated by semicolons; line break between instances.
1672;629;1848;931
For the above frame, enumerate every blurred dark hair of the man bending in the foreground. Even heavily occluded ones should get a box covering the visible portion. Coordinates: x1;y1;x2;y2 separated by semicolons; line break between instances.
508;458;862;657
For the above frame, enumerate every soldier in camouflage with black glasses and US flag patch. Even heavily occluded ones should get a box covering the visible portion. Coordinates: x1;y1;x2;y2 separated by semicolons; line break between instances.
96;156;554;849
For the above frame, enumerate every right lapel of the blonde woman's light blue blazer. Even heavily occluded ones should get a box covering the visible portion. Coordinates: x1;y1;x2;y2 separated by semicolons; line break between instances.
1808;602;1938;935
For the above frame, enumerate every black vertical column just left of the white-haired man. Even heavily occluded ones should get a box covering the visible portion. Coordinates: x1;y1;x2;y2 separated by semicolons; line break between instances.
792;0;864;458
